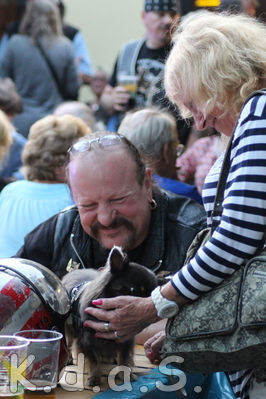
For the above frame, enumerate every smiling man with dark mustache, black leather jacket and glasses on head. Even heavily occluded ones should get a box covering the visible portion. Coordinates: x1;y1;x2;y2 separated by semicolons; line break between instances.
16;132;205;278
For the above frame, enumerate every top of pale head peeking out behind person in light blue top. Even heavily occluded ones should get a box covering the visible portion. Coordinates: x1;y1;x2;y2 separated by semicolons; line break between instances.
54;101;95;130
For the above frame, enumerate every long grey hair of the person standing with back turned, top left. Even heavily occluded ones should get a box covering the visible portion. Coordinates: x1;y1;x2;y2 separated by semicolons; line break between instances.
19;0;63;40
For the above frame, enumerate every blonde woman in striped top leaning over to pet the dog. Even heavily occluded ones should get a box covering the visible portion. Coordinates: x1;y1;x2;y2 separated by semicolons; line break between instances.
85;12;266;399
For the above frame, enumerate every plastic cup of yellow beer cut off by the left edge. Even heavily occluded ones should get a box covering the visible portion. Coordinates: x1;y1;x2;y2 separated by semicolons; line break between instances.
0;335;29;399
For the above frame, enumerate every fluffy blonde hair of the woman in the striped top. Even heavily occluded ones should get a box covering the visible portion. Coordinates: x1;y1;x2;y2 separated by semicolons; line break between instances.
164;11;266;118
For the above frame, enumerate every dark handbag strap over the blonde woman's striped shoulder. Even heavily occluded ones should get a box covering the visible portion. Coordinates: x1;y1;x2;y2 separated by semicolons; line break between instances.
211;88;266;233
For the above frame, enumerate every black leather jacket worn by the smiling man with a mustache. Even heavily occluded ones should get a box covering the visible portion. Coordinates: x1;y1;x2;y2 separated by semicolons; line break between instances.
16;191;206;278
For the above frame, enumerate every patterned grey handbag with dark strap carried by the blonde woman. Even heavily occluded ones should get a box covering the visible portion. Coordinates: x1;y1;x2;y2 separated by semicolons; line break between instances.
162;91;266;373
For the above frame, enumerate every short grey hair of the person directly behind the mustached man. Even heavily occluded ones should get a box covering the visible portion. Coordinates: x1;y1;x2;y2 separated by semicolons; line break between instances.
118;108;178;159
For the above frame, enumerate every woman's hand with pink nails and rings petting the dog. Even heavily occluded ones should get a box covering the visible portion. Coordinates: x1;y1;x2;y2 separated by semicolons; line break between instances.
84;296;159;342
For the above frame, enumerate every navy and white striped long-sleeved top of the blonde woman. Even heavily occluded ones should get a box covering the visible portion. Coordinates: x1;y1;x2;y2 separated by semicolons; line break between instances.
172;95;266;300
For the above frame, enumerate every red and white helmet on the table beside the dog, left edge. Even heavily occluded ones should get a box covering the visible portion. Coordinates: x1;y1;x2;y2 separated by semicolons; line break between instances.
0;258;70;335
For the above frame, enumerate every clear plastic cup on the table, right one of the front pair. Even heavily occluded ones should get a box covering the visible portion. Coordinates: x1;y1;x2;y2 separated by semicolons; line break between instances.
14;330;63;399
